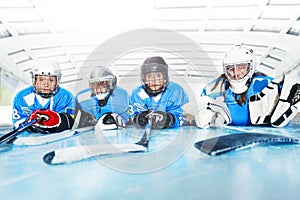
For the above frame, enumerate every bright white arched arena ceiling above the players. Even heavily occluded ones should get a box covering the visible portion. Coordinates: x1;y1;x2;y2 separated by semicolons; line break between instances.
0;0;300;92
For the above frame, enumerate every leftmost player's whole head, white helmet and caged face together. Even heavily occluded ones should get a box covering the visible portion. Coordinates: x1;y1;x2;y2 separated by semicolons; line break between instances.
31;63;61;98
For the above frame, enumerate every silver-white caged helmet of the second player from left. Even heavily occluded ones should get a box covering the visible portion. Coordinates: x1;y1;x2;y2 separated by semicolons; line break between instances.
88;66;117;100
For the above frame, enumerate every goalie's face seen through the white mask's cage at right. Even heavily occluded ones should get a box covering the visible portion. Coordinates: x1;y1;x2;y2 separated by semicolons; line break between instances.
226;63;249;80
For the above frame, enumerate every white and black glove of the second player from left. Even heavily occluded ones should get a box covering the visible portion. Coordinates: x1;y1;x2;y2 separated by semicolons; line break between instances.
95;112;126;131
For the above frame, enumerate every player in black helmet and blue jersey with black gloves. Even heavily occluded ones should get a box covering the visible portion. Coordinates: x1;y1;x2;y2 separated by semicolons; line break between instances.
130;57;189;129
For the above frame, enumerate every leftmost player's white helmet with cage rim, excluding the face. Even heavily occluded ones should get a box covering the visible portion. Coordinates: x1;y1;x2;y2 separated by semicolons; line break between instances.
30;60;61;98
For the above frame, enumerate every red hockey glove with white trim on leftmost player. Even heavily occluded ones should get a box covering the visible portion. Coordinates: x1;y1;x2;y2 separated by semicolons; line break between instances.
28;109;61;128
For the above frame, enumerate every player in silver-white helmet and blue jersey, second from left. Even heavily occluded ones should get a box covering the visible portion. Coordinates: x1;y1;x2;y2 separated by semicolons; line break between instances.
76;67;129;130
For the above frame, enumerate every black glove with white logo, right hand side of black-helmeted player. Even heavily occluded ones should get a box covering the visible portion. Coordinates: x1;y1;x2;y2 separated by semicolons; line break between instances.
147;111;175;129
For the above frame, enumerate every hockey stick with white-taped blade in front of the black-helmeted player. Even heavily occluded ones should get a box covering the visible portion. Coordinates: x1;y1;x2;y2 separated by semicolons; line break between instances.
43;119;152;165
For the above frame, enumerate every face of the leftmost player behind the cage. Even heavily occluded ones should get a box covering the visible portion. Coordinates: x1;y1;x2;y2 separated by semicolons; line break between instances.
34;75;57;93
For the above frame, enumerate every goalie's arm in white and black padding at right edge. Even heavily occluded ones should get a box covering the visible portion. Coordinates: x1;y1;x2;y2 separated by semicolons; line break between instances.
249;75;300;127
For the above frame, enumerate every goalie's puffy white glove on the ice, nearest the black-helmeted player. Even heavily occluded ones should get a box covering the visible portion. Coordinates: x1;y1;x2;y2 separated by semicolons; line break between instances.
195;96;231;128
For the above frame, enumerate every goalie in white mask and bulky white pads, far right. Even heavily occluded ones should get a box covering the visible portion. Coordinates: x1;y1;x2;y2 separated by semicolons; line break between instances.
195;45;300;128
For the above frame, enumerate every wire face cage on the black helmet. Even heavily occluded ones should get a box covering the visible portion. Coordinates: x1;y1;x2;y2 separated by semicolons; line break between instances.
141;63;169;96
